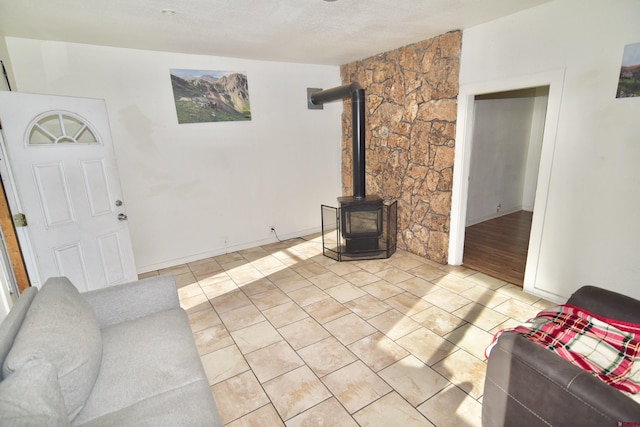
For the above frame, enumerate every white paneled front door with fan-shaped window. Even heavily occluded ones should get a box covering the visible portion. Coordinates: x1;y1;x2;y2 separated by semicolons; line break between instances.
0;92;137;291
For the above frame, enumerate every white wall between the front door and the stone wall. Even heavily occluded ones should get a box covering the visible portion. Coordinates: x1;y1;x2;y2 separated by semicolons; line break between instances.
7;38;342;272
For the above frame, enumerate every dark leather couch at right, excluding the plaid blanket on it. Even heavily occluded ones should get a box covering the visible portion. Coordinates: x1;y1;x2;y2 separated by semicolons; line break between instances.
482;286;640;427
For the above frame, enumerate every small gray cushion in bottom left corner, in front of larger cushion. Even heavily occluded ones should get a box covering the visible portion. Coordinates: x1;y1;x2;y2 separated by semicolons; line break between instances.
0;359;69;427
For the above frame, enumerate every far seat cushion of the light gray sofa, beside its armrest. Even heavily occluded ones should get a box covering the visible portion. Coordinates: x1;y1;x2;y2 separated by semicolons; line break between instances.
73;308;215;425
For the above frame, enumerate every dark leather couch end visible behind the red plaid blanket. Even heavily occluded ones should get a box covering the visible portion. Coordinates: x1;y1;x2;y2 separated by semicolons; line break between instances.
567;286;640;323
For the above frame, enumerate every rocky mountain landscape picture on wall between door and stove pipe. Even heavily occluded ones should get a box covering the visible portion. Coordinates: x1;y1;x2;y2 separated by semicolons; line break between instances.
170;69;251;124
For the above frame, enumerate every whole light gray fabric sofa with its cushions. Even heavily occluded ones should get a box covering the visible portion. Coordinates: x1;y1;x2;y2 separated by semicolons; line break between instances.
0;276;222;427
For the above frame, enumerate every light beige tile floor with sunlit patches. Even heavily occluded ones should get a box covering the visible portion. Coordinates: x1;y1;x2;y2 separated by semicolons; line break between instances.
141;235;554;427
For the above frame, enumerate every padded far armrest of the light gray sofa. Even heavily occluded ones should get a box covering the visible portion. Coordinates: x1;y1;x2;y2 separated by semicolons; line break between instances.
82;276;180;328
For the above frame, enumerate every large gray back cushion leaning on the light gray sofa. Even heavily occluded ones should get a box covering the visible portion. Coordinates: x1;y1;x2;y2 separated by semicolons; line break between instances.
2;277;102;418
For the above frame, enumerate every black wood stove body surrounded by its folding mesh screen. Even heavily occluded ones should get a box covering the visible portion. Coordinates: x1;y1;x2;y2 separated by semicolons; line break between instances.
321;201;398;261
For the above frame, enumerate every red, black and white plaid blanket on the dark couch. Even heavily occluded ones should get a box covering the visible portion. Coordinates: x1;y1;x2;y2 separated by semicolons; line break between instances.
485;305;640;394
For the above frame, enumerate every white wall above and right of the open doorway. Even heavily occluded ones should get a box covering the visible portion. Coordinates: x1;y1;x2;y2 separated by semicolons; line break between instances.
459;0;640;300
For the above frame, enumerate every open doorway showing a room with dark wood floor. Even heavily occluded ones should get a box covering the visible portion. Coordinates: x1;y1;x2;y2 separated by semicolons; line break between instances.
463;86;549;286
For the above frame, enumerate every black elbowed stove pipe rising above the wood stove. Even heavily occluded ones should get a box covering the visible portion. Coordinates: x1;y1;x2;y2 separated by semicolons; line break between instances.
310;82;365;199
